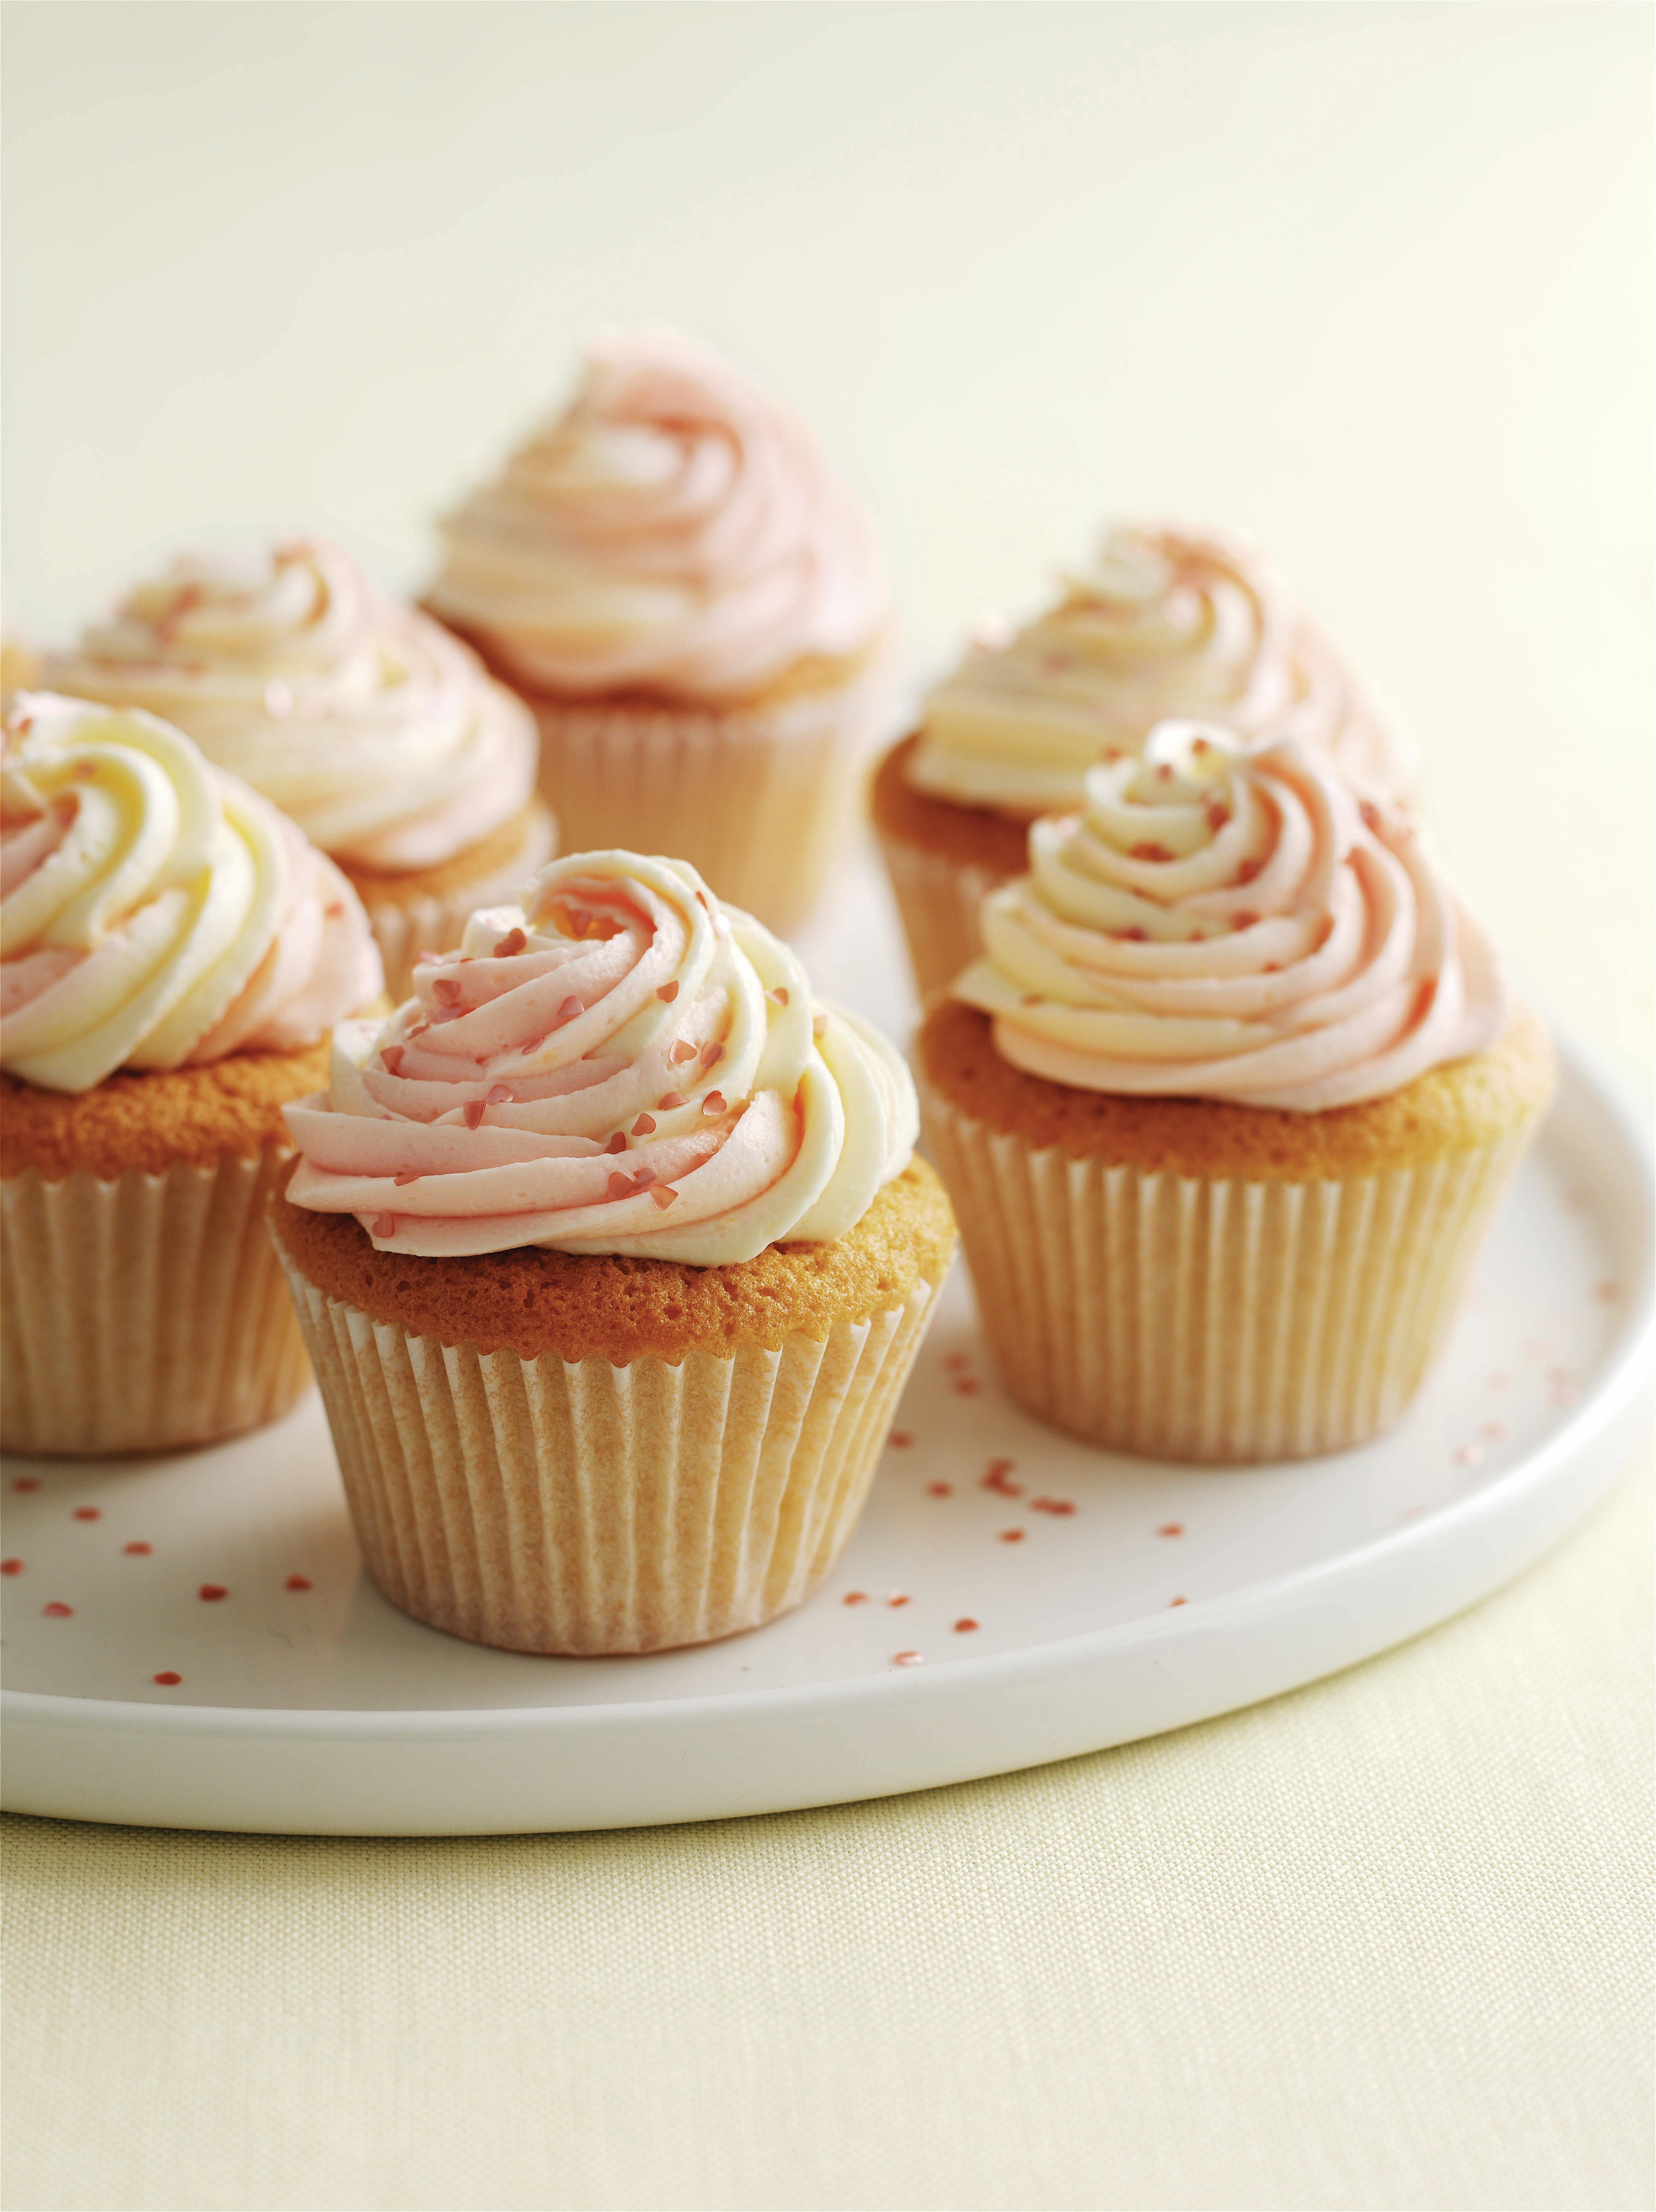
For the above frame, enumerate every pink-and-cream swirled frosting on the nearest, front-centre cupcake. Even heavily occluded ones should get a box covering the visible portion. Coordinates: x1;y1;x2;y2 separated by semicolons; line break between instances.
287;852;918;1268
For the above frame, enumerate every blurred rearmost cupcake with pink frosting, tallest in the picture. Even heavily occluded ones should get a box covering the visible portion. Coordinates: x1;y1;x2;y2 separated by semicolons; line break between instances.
427;332;889;929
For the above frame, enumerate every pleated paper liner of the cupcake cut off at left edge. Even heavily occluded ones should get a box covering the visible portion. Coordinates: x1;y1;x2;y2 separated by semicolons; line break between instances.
0;1146;310;1453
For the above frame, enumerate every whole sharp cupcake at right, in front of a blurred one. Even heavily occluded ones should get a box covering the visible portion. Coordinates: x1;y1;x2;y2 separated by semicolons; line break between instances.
918;723;1552;1460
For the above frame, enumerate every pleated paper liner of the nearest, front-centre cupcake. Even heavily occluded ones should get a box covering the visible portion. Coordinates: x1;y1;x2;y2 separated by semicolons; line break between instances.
287;1265;935;1655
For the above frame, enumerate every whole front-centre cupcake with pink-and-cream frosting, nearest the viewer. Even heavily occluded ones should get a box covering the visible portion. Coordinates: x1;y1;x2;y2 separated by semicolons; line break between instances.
274;852;955;1652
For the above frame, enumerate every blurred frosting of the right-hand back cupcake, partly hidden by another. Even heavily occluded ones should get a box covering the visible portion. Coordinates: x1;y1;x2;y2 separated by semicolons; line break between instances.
909;526;1409;821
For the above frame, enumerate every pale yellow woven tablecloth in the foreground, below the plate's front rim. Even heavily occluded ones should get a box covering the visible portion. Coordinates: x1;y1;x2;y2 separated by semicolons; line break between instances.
4;1467;1652;2212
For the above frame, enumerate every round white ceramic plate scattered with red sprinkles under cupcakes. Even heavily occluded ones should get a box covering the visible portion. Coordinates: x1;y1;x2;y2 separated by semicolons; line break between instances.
2;858;1652;1836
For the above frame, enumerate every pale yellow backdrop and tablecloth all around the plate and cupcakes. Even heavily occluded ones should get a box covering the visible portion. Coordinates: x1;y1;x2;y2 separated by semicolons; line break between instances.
4;4;1652;2212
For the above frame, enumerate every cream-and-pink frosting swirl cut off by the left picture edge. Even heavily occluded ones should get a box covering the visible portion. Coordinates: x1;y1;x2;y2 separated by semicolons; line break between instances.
0;692;380;1090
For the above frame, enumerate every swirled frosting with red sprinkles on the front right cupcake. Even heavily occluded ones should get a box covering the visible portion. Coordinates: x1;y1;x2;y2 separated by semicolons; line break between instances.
953;721;1510;1113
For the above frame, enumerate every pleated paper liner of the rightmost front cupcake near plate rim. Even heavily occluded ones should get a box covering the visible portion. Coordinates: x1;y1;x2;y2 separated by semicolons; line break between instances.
922;1084;1530;1460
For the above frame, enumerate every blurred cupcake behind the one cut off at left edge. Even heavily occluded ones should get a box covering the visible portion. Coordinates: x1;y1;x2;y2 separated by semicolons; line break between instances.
46;537;555;998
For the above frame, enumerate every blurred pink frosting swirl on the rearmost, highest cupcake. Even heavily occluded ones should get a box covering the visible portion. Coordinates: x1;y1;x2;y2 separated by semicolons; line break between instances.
429;330;884;703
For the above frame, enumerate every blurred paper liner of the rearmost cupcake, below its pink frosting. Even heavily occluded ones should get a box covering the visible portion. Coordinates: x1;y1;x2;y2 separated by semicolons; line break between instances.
531;661;884;933
